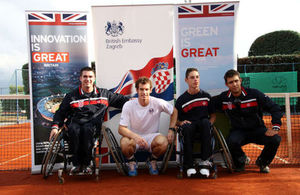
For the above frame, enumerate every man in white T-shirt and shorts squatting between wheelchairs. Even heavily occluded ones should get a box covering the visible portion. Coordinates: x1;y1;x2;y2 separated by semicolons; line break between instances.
119;77;177;176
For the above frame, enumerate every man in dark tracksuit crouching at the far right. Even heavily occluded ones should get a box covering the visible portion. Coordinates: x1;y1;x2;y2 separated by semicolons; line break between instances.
215;70;282;173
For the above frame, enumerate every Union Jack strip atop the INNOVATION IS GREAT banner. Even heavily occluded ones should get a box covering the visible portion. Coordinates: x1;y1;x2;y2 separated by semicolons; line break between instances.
28;12;87;26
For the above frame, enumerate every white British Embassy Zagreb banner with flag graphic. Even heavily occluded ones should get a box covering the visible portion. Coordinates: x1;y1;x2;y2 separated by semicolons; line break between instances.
92;5;174;163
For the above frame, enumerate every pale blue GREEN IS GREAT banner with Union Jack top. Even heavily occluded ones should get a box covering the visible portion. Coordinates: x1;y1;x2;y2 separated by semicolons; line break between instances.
175;2;239;97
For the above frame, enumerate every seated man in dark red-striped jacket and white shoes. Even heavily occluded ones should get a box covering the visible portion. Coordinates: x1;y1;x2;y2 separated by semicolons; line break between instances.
175;68;216;177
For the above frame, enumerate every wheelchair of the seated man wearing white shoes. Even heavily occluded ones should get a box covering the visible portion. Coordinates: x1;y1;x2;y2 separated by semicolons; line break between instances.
176;126;233;179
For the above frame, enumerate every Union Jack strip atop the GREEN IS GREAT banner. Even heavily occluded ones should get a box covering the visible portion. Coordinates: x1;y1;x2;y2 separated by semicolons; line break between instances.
178;3;235;18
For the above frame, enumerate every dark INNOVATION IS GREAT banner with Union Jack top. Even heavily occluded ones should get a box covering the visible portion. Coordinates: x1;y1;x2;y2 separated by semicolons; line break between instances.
26;11;89;173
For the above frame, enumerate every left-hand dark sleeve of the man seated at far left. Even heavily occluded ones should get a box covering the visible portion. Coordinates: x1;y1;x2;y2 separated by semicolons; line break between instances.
52;94;71;128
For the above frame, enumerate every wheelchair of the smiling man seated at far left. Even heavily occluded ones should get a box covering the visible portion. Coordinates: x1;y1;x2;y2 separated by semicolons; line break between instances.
41;126;128;184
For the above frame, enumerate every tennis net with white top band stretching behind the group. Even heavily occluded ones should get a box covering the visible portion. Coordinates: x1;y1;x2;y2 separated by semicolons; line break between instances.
0;93;300;170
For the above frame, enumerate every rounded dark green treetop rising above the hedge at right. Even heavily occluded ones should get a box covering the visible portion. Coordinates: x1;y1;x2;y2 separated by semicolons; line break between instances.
248;30;300;56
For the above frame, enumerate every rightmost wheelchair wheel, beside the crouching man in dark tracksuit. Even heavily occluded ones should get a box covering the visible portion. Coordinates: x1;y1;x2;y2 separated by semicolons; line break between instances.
213;127;233;173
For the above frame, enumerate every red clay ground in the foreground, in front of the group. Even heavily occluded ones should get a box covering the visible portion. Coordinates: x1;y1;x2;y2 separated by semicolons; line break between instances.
0;168;300;195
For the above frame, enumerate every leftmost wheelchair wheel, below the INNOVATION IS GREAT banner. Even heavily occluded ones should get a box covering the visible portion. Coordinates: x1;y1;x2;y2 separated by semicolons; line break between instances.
41;129;63;179
